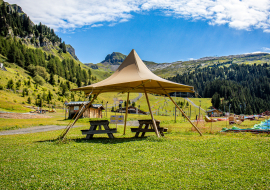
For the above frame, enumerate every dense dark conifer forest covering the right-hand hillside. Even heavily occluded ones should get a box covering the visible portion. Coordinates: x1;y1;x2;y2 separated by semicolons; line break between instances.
168;63;270;114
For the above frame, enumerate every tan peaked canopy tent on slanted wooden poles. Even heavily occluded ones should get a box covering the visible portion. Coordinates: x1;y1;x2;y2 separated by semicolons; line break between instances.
59;49;202;137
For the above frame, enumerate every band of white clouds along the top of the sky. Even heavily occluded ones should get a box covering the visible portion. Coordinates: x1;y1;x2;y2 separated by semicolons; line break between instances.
7;0;270;32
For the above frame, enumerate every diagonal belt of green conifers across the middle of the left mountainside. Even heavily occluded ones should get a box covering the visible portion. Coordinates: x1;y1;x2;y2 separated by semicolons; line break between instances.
0;37;93;87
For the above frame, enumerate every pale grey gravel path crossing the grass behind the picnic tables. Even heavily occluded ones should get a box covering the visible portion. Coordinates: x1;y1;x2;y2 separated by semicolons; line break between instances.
0;121;139;135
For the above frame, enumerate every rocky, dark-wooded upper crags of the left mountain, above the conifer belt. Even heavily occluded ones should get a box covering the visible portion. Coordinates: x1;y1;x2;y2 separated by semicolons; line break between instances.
0;1;79;60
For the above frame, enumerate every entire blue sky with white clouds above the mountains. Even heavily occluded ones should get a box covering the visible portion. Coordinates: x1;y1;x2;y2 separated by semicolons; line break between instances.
8;0;270;63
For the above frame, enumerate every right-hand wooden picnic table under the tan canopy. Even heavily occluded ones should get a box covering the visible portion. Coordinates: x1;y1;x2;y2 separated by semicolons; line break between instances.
131;119;168;137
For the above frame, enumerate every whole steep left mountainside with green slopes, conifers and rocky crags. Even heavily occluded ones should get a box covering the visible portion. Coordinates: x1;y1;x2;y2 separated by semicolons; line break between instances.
0;0;106;110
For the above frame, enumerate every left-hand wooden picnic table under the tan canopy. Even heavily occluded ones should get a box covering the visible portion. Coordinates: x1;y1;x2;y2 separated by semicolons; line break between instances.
81;120;117;139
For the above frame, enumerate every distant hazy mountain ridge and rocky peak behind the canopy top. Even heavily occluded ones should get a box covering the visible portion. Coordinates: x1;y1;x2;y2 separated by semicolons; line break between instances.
85;52;270;78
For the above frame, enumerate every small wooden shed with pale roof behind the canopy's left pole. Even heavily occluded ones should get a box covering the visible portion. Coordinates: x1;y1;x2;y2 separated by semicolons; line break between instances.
67;101;105;119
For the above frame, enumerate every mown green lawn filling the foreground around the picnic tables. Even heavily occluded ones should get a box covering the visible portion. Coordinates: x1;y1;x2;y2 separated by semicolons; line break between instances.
0;119;270;189
